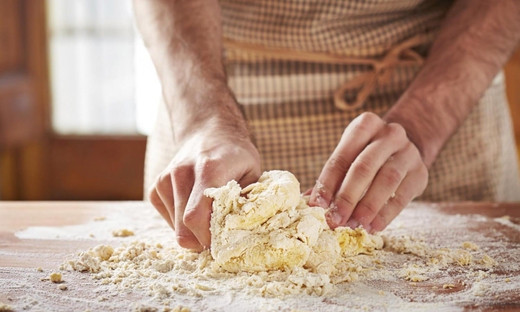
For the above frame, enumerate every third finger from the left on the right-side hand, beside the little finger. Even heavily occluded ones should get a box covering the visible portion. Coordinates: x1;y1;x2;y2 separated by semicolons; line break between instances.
346;148;411;231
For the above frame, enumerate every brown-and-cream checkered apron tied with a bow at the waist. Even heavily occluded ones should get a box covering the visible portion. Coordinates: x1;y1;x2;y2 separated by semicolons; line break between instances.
145;0;520;201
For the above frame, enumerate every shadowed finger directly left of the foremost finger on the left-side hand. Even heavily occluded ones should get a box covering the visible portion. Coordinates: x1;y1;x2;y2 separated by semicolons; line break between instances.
171;166;202;251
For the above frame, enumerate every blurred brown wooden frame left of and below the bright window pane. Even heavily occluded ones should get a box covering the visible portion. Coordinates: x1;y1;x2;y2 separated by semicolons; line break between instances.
0;0;146;200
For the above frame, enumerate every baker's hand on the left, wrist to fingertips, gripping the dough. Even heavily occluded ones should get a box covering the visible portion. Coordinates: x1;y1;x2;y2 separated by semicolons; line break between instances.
148;126;261;251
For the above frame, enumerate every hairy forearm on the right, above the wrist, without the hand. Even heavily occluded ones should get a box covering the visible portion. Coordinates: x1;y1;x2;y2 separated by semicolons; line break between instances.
384;0;520;167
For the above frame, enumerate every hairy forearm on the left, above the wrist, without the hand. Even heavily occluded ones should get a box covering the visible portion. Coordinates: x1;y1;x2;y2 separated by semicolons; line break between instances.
134;0;247;140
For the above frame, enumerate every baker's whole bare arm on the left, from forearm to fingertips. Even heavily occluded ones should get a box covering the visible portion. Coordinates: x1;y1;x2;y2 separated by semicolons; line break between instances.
134;0;260;250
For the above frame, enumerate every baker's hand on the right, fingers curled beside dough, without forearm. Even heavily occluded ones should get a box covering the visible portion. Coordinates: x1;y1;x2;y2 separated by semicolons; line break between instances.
309;113;428;232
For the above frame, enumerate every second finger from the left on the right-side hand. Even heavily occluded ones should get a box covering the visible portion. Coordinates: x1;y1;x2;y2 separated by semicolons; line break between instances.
328;124;409;227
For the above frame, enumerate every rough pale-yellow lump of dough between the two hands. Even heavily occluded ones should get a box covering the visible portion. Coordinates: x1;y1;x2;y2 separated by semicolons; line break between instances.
204;170;383;275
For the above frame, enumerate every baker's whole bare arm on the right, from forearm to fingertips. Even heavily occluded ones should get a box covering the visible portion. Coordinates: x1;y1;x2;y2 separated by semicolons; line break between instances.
310;0;520;231
